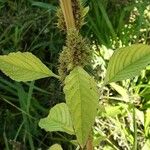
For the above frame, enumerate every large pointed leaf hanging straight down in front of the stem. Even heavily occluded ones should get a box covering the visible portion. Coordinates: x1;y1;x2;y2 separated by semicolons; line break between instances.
64;67;99;148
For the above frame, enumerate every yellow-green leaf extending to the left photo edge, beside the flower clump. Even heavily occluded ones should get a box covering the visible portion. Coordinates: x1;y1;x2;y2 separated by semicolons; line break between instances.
0;52;58;82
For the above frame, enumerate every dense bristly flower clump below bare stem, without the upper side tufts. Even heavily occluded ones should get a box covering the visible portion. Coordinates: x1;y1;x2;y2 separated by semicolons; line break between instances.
58;29;92;80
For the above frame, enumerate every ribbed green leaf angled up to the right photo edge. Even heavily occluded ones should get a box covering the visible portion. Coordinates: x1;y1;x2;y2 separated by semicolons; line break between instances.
104;44;150;84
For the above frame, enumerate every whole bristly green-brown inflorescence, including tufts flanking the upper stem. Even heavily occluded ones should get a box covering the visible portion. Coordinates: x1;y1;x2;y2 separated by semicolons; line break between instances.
57;0;92;82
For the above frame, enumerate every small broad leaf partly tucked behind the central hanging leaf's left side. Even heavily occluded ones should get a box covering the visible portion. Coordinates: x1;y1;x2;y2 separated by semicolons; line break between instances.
39;103;74;134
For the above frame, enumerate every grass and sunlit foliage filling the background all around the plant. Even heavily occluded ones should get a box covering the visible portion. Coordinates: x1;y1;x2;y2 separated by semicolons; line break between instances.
0;0;150;150
